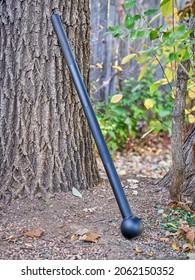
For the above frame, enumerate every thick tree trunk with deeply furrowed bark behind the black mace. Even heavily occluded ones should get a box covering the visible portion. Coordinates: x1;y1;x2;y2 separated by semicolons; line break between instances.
0;0;99;201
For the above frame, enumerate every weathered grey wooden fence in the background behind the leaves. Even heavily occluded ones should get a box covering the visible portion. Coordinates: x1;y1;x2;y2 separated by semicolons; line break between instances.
90;0;182;102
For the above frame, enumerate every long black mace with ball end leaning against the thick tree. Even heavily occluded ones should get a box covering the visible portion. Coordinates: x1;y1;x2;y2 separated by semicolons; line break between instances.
51;14;142;238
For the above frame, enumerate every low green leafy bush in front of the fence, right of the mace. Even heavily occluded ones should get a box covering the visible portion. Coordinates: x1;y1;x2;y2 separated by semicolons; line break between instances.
95;70;173;151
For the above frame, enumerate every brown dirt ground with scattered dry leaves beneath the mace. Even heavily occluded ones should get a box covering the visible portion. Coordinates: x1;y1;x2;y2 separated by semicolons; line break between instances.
0;143;193;260
